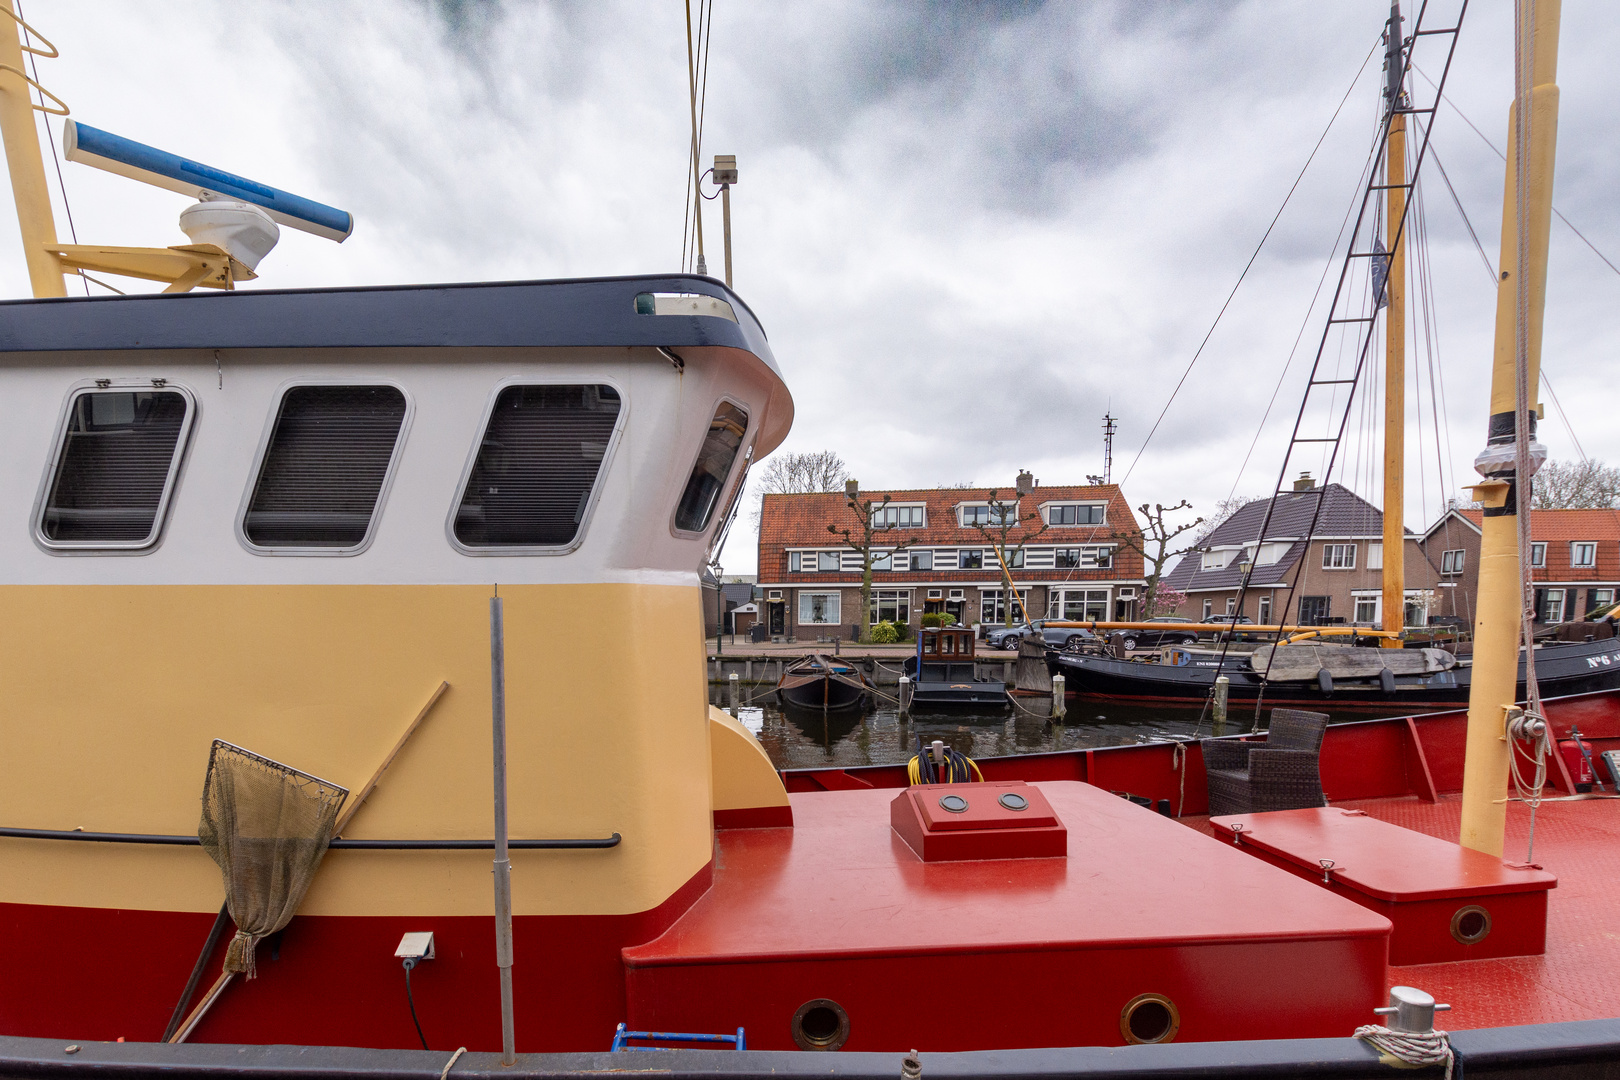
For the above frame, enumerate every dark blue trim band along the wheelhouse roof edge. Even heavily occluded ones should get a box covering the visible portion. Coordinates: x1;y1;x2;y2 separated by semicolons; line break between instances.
0;275;776;371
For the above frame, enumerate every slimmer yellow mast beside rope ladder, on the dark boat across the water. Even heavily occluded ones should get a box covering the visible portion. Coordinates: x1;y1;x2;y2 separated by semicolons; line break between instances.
1380;0;1406;649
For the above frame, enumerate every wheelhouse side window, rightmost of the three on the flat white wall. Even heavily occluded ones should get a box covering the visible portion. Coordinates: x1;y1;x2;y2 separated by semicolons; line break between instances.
455;385;619;547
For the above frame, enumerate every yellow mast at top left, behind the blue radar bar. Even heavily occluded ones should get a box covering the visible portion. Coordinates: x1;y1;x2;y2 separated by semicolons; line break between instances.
0;0;68;296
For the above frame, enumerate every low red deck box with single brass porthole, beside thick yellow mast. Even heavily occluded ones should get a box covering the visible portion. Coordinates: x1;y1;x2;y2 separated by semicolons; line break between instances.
1210;806;1558;965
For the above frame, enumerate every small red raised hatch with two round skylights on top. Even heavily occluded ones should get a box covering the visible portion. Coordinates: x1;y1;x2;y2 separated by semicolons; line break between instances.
889;780;1069;863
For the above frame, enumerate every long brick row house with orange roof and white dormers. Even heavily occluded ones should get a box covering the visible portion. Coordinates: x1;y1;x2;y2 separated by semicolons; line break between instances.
758;484;1145;638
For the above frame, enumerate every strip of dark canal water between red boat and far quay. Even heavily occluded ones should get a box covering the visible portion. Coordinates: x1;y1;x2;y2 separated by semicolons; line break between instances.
710;685;1251;769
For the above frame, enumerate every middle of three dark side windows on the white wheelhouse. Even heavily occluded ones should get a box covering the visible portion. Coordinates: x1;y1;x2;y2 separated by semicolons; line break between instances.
241;385;405;549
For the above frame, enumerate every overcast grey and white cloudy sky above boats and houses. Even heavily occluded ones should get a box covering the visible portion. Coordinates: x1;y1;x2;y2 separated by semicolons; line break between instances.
0;0;1620;572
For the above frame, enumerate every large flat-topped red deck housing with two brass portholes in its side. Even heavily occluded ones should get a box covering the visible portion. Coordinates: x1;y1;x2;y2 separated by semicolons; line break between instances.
624;782;1390;1049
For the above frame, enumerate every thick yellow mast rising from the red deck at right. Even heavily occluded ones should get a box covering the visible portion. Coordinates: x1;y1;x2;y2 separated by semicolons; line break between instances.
1460;0;1560;857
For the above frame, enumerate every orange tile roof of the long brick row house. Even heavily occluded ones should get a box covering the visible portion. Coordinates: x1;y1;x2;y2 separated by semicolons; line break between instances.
760;484;1142;583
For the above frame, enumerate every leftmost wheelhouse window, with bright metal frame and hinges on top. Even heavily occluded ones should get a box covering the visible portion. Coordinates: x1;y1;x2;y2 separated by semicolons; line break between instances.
39;389;191;549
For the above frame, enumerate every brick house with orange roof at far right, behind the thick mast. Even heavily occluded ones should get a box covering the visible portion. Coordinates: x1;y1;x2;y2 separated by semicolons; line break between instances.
1408;510;1620;625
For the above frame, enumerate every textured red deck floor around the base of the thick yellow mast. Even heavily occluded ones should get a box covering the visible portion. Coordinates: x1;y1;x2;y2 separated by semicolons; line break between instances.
1184;795;1620;1030
